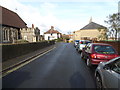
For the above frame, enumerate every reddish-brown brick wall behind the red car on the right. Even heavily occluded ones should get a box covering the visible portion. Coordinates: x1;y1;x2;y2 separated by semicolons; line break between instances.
94;41;120;55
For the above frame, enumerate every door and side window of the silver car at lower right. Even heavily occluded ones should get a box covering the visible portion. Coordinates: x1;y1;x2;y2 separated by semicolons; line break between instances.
103;59;120;89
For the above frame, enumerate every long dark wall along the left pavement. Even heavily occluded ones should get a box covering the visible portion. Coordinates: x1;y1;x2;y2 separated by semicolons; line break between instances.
2;41;55;61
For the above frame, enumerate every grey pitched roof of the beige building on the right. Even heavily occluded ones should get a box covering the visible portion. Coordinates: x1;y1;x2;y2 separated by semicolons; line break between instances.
80;22;106;30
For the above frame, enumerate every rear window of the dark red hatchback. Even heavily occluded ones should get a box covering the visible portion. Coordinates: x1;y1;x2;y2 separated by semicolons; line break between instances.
94;45;116;54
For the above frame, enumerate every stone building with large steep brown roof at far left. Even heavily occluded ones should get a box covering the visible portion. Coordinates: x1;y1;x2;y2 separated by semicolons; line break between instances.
0;6;27;43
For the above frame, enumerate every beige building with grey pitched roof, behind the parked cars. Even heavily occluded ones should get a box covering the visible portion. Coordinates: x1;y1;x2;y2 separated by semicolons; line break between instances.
73;20;107;40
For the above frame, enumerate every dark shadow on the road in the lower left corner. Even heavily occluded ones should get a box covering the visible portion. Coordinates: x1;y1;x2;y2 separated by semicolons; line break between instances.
2;71;31;88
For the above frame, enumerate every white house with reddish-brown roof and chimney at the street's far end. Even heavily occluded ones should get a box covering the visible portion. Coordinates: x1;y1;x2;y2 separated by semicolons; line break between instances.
44;26;61;40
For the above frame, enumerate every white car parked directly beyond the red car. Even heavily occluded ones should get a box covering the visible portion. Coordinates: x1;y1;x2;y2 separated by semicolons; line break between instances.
76;40;91;53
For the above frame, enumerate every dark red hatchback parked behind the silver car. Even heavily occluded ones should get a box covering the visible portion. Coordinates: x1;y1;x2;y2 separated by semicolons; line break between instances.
81;43;118;66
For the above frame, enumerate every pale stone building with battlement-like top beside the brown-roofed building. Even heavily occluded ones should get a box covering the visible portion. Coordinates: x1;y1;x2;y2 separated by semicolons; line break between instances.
20;24;40;42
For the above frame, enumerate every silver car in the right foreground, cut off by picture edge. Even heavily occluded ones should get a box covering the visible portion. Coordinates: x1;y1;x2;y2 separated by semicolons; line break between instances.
95;57;120;90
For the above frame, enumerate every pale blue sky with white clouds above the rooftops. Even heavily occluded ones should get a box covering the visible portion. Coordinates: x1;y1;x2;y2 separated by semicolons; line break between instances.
0;0;120;35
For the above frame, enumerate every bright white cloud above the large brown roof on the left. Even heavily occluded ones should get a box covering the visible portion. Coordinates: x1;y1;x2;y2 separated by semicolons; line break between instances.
0;0;58;34
